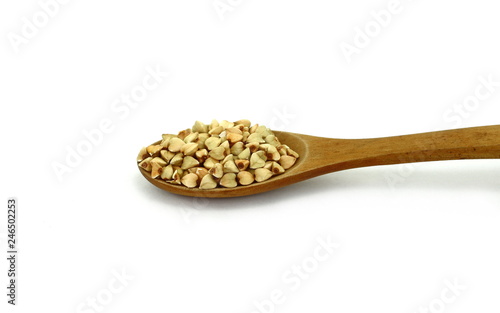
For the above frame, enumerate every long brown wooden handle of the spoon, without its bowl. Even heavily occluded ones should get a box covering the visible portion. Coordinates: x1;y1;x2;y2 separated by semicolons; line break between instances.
323;125;500;171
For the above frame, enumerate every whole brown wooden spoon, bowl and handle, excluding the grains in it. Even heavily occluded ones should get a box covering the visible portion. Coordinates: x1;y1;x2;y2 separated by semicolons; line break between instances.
139;125;500;198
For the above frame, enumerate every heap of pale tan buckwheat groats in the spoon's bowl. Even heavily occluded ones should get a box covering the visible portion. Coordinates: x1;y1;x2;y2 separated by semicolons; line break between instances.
137;120;299;189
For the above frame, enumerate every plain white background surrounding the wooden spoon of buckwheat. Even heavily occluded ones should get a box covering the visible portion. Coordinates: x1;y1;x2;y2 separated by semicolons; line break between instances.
0;0;500;313
